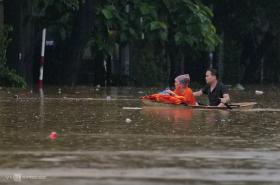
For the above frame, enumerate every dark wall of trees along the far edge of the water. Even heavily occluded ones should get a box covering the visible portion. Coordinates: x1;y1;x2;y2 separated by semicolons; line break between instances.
2;0;280;86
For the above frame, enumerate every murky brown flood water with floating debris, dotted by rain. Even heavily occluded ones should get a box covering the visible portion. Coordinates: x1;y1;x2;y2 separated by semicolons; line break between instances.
0;87;280;185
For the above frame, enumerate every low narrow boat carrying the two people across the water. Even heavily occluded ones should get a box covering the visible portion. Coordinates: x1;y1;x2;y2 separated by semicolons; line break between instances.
142;100;257;110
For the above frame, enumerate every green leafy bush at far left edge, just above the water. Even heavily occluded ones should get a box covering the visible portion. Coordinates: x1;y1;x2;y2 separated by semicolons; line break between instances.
0;27;26;88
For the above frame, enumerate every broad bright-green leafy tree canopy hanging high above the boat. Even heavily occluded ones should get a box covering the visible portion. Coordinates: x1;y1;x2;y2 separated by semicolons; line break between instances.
91;0;220;59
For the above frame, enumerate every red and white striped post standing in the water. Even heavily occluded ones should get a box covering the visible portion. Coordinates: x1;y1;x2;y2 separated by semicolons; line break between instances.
38;28;47;89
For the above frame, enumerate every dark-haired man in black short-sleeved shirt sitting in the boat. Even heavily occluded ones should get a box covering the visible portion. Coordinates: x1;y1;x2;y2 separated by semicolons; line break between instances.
193;69;230;107
